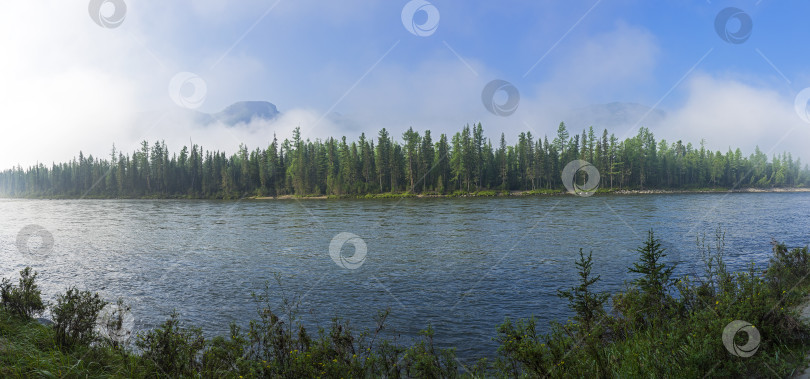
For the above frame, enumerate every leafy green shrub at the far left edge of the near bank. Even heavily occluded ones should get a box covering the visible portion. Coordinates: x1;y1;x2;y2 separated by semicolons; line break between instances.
0;267;45;319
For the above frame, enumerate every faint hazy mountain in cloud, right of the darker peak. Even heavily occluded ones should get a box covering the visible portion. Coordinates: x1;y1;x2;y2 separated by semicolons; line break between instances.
564;102;667;130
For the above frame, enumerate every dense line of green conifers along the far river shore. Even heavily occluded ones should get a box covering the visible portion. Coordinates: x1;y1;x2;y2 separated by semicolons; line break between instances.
0;123;810;198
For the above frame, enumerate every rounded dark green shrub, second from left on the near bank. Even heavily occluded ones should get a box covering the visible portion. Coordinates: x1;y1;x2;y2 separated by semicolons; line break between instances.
51;287;107;346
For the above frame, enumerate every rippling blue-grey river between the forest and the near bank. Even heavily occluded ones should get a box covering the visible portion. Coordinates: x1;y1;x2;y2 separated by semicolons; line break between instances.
0;193;810;360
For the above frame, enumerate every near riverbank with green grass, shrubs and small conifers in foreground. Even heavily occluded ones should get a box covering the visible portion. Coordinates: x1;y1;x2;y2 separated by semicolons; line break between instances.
0;232;810;378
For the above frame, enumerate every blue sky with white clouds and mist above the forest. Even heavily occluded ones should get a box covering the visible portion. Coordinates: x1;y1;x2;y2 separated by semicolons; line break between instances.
0;0;810;169
